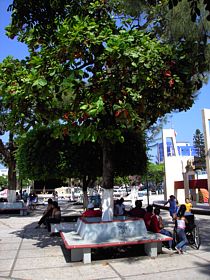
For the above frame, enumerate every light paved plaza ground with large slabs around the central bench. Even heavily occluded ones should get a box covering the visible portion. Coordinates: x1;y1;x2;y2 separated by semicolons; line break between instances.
0;197;210;280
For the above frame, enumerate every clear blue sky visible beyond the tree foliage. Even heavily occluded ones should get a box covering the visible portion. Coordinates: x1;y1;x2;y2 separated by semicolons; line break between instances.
0;0;210;153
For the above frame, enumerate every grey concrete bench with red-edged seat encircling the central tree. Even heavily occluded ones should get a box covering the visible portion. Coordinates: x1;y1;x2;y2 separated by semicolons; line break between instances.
60;218;172;264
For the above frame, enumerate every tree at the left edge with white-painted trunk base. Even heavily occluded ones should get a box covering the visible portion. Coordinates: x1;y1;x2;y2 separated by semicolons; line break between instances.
0;57;60;201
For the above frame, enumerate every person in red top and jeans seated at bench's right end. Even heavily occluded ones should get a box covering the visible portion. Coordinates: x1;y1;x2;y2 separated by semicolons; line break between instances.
150;207;172;249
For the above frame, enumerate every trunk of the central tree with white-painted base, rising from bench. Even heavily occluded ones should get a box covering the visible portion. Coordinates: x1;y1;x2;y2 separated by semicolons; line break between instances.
102;139;114;221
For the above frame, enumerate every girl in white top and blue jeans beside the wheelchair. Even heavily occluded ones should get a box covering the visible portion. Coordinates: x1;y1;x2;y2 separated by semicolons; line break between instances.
175;204;188;254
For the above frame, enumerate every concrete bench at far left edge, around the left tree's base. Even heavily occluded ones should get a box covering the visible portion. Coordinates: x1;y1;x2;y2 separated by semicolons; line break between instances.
0;201;28;216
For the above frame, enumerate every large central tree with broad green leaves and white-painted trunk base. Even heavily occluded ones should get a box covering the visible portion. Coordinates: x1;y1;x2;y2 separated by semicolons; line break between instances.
1;0;206;219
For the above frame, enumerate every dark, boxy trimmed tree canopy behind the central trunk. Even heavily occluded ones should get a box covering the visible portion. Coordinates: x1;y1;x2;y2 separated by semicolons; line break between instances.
16;126;147;180
